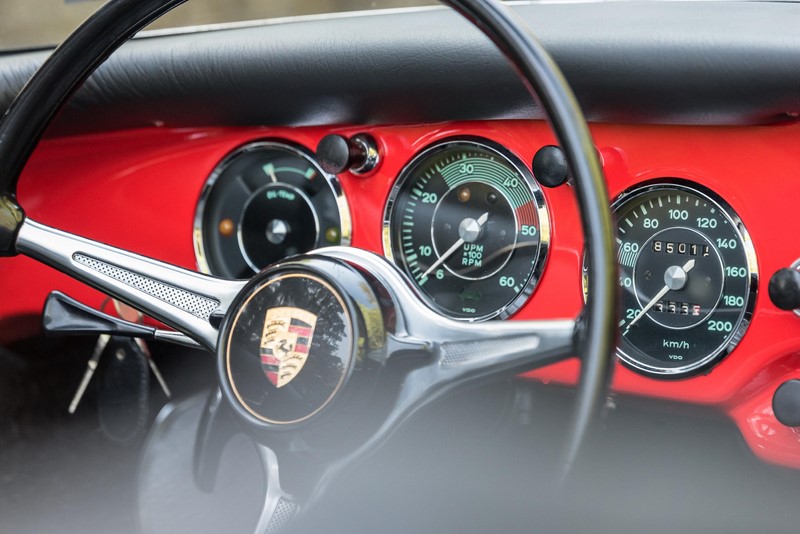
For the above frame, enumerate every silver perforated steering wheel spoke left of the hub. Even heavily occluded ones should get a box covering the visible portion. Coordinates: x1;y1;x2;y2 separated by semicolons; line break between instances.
16;219;245;350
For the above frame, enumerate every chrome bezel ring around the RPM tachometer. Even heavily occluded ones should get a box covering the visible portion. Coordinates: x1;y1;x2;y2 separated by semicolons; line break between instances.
383;136;550;322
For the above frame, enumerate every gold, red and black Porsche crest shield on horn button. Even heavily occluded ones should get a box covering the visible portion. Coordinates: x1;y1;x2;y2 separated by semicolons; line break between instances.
261;307;317;388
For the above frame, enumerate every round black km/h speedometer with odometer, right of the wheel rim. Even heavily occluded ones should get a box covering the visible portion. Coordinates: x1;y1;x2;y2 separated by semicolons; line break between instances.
592;180;758;377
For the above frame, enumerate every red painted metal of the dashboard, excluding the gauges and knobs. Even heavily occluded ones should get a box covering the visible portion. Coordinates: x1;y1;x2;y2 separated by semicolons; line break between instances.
0;121;800;468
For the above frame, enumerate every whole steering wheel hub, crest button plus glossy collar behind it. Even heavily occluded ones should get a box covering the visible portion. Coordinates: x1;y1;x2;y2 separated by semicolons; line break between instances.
217;257;385;426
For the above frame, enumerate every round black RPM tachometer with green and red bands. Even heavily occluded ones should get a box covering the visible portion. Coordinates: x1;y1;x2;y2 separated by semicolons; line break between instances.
384;138;550;321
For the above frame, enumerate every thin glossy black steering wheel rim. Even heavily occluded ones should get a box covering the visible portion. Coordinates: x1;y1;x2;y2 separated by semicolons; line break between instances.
0;0;617;520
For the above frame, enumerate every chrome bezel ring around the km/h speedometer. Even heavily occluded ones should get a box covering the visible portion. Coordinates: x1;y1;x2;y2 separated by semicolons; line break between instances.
608;178;758;379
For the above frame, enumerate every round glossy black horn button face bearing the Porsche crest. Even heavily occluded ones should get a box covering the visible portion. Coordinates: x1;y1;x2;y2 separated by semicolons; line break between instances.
224;272;355;424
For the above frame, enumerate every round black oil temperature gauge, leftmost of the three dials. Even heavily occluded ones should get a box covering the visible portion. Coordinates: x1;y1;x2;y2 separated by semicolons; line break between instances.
194;141;350;278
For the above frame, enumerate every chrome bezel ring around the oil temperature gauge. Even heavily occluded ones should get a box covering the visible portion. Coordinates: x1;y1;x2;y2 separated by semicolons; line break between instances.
192;139;352;274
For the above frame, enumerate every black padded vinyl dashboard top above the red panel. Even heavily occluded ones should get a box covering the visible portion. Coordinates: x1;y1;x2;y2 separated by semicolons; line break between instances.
0;1;800;142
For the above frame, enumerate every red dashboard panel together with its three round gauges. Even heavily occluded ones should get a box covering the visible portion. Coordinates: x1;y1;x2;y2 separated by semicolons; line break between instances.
14;120;800;468
